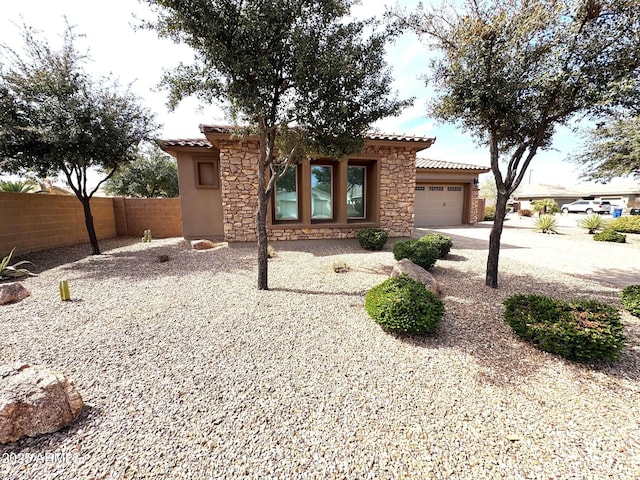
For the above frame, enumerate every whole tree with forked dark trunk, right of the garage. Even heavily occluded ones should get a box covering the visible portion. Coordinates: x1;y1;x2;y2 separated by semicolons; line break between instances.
392;0;640;288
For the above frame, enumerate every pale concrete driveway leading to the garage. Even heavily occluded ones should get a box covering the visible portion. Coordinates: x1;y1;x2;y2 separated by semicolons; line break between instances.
414;214;640;288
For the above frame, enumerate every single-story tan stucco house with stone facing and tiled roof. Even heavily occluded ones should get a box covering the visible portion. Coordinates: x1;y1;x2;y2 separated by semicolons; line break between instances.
158;125;488;242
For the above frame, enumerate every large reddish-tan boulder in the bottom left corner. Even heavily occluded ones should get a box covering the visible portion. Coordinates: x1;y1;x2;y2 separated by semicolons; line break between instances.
0;362;83;444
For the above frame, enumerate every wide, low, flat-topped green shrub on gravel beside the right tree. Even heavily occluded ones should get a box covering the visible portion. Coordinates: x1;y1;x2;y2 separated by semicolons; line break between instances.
504;294;625;362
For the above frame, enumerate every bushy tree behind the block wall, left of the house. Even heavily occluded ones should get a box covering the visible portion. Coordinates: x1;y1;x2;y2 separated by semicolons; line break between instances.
104;145;178;198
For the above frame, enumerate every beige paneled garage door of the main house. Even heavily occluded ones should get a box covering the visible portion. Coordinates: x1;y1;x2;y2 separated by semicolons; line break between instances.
415;184;464;227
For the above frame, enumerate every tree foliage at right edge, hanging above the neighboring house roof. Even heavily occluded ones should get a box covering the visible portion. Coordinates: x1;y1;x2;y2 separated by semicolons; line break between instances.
574;115;640;182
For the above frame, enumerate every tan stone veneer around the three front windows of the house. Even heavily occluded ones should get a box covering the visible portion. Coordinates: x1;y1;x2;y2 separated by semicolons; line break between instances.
220;141;416;242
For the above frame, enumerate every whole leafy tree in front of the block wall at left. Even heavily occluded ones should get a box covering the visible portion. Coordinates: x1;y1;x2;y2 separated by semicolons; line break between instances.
0;26;156;254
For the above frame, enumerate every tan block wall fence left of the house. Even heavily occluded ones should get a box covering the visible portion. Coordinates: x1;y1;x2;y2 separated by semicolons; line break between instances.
0;192;182;258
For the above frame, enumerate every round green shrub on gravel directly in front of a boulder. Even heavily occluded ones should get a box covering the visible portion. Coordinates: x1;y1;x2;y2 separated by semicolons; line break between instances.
364;275;444;335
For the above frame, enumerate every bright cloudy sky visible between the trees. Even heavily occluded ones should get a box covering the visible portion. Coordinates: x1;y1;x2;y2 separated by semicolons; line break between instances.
0;0;616;185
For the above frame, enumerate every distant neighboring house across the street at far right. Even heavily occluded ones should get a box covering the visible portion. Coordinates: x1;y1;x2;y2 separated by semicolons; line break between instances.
513;182;640;209
